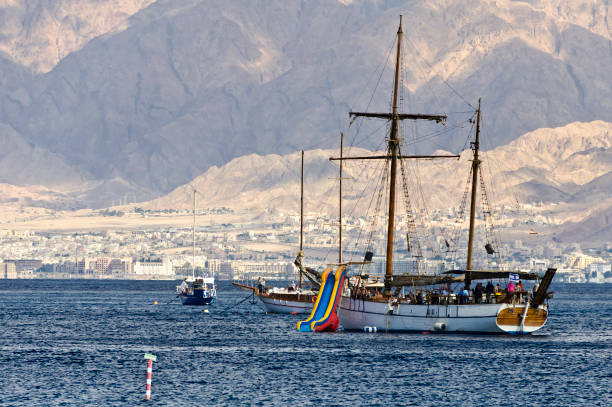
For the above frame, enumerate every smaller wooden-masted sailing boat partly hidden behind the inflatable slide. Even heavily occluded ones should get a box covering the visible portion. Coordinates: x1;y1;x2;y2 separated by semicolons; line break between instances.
232;151;321;314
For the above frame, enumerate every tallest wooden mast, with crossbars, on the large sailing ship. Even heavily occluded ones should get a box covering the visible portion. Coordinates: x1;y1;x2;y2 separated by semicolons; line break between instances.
385;16;403;294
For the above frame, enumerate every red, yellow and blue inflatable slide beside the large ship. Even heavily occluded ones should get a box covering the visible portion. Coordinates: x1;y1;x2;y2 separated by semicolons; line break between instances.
297;266;346;332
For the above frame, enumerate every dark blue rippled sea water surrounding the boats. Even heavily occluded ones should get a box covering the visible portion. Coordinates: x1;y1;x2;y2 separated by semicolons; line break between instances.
0;280;612;406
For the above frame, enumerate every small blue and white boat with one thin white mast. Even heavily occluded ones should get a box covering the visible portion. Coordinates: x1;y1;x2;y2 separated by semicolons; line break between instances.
176;188;217;306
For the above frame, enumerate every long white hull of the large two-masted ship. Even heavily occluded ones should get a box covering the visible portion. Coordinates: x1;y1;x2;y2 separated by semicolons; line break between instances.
338;296;545;334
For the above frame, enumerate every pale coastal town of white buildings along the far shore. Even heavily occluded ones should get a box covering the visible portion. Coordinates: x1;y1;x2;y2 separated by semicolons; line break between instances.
0;208;612;283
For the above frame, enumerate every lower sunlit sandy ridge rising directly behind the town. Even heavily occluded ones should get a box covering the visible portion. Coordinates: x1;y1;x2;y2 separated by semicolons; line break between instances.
143;121;612;241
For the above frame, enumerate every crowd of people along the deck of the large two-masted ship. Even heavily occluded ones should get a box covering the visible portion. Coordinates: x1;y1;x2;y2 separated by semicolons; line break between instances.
353;280;538;306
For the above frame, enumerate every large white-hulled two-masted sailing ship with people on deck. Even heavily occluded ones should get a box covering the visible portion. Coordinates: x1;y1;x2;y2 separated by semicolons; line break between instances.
330;16;556;334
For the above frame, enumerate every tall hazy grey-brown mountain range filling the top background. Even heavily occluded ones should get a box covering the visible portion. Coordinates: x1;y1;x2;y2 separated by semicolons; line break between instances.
0;0;612;206
